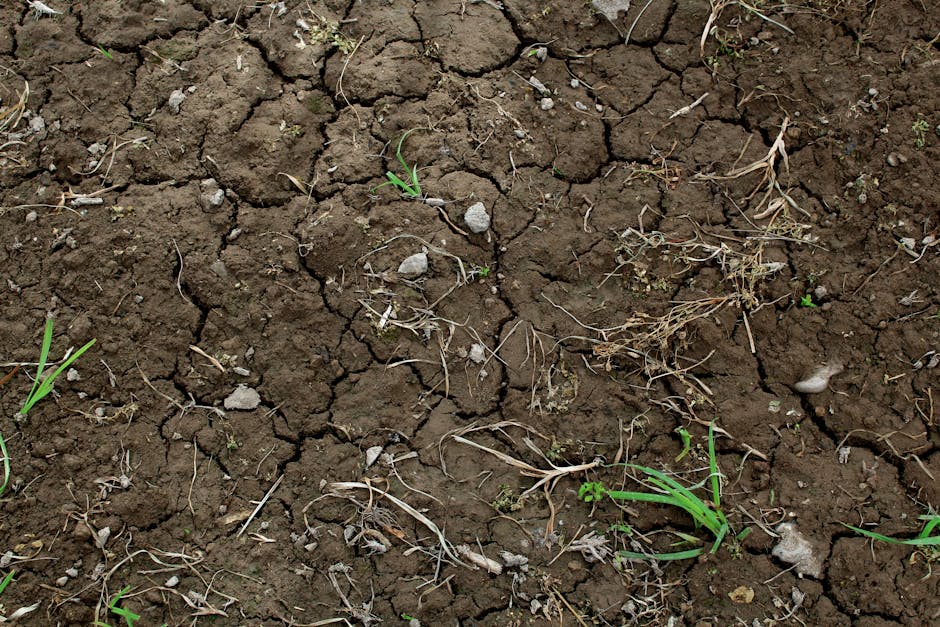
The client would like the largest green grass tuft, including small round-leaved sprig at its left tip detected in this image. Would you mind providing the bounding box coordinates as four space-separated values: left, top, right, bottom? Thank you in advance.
578 425 743 561
